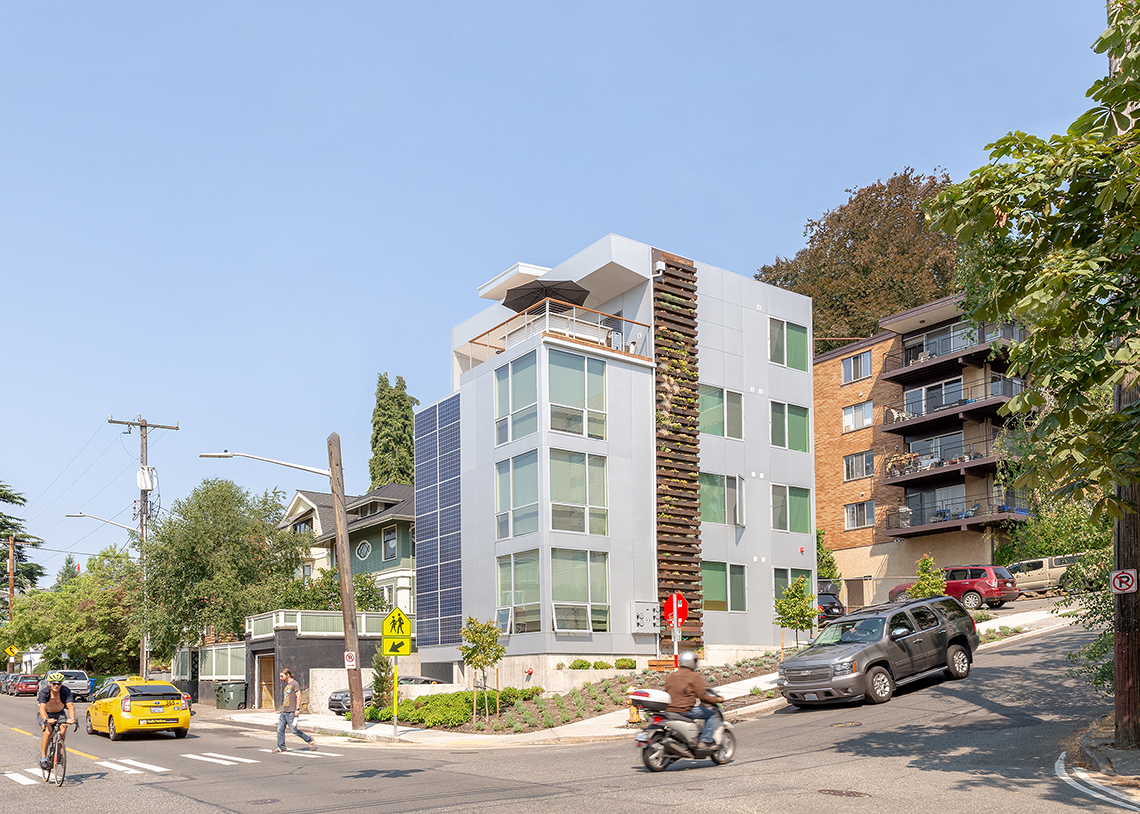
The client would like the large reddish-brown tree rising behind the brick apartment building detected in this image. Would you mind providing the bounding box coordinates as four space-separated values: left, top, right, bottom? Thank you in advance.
756 166 958 353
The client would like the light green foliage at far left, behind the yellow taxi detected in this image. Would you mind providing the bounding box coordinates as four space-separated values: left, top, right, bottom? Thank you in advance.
5 547 140 673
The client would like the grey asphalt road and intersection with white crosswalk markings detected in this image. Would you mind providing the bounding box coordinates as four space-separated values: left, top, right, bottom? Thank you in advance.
0 629 1119 814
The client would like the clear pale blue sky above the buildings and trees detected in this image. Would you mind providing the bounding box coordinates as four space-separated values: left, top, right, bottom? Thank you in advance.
0 0 1106 576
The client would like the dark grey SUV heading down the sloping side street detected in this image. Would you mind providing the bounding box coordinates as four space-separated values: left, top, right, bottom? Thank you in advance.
776 596 979 707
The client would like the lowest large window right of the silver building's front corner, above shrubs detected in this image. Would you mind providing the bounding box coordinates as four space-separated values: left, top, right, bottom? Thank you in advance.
551 548 610 633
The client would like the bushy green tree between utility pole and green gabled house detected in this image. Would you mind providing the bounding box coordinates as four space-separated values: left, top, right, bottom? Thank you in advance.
144 480 306 657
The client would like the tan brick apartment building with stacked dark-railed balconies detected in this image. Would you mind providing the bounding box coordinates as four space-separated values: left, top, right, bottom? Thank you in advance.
813 296 1026 605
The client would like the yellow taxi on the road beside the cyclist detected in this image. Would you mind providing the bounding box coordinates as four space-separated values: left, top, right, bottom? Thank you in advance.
87 676 190 741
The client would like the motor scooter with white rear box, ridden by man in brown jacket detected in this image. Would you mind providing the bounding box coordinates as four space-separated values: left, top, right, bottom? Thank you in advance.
627 690 736 772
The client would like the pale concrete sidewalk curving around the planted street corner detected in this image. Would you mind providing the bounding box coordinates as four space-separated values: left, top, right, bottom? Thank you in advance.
202 611 1069 749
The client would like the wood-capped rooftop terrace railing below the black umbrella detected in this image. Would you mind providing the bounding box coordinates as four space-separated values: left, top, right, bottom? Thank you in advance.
456 299 653 371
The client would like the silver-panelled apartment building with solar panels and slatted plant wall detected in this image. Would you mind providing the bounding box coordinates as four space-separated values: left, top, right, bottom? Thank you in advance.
415 235 815 664
